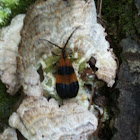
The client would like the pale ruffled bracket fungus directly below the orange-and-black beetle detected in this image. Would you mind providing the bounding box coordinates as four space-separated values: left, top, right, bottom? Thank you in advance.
9 97 98 140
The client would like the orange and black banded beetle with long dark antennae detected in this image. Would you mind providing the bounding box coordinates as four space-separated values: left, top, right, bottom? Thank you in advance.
40 27 79 99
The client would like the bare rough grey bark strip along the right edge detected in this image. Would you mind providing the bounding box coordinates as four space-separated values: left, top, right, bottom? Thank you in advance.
113 37 140 140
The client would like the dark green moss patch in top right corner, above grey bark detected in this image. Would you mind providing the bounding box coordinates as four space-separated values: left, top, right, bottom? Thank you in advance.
102 0 140 44
